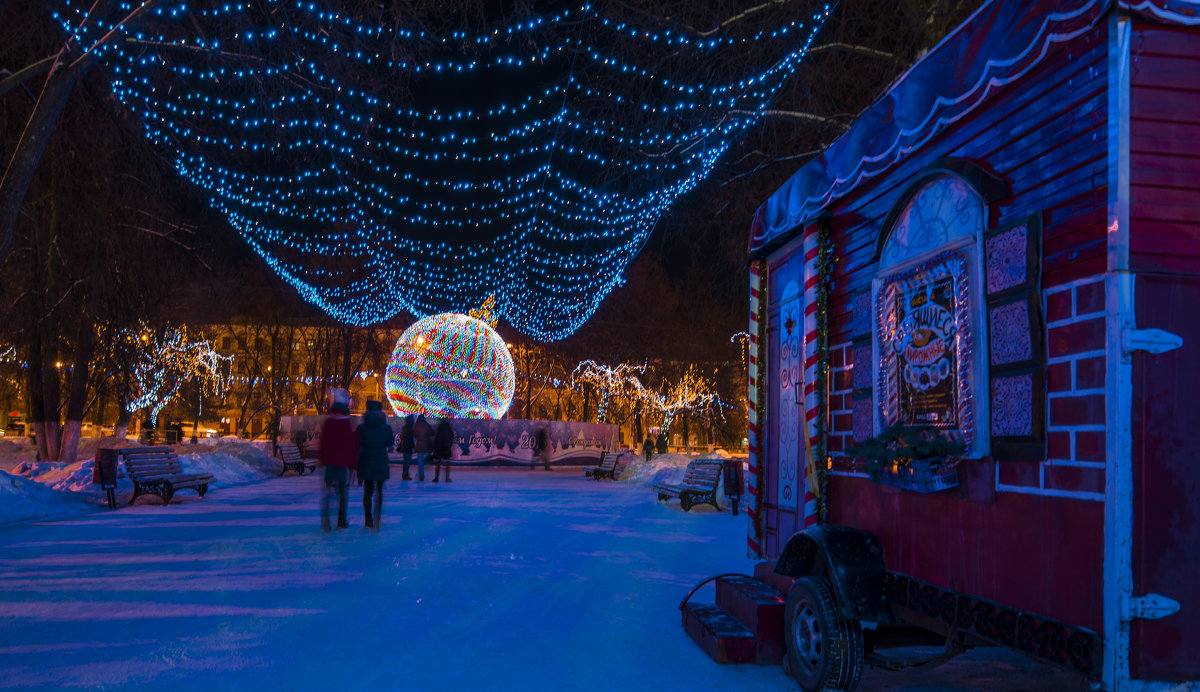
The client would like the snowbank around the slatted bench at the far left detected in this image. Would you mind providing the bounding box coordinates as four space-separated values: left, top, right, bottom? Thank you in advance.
0 438 281 524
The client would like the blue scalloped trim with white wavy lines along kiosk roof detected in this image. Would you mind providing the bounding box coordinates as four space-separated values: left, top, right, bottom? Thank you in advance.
750 0 1200 254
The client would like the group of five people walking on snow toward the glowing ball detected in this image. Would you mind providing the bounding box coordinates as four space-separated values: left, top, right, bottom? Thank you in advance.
320 391 454 531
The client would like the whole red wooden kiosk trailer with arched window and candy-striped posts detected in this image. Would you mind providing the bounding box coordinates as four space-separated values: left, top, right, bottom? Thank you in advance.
685 0 1200 690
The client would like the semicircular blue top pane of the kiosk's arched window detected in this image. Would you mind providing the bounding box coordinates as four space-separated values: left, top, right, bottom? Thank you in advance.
880 175 985 267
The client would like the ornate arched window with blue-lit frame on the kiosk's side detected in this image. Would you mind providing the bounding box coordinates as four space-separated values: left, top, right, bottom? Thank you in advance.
871 172 990 458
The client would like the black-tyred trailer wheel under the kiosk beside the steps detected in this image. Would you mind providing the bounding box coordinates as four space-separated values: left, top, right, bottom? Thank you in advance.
784 577 863 692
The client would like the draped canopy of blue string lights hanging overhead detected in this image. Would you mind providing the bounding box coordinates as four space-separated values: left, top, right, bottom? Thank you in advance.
55 0 830 341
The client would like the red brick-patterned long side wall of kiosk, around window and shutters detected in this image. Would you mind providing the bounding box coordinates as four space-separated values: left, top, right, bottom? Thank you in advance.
801 13 1108 631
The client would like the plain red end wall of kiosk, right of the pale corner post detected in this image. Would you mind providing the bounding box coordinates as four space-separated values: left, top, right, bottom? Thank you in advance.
1129 23 1200 680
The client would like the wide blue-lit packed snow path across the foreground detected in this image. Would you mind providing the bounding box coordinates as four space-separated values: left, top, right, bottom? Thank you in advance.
0 469 1089 692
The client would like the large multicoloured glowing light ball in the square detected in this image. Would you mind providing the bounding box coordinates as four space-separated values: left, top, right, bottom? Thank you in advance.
388 312 516 419
